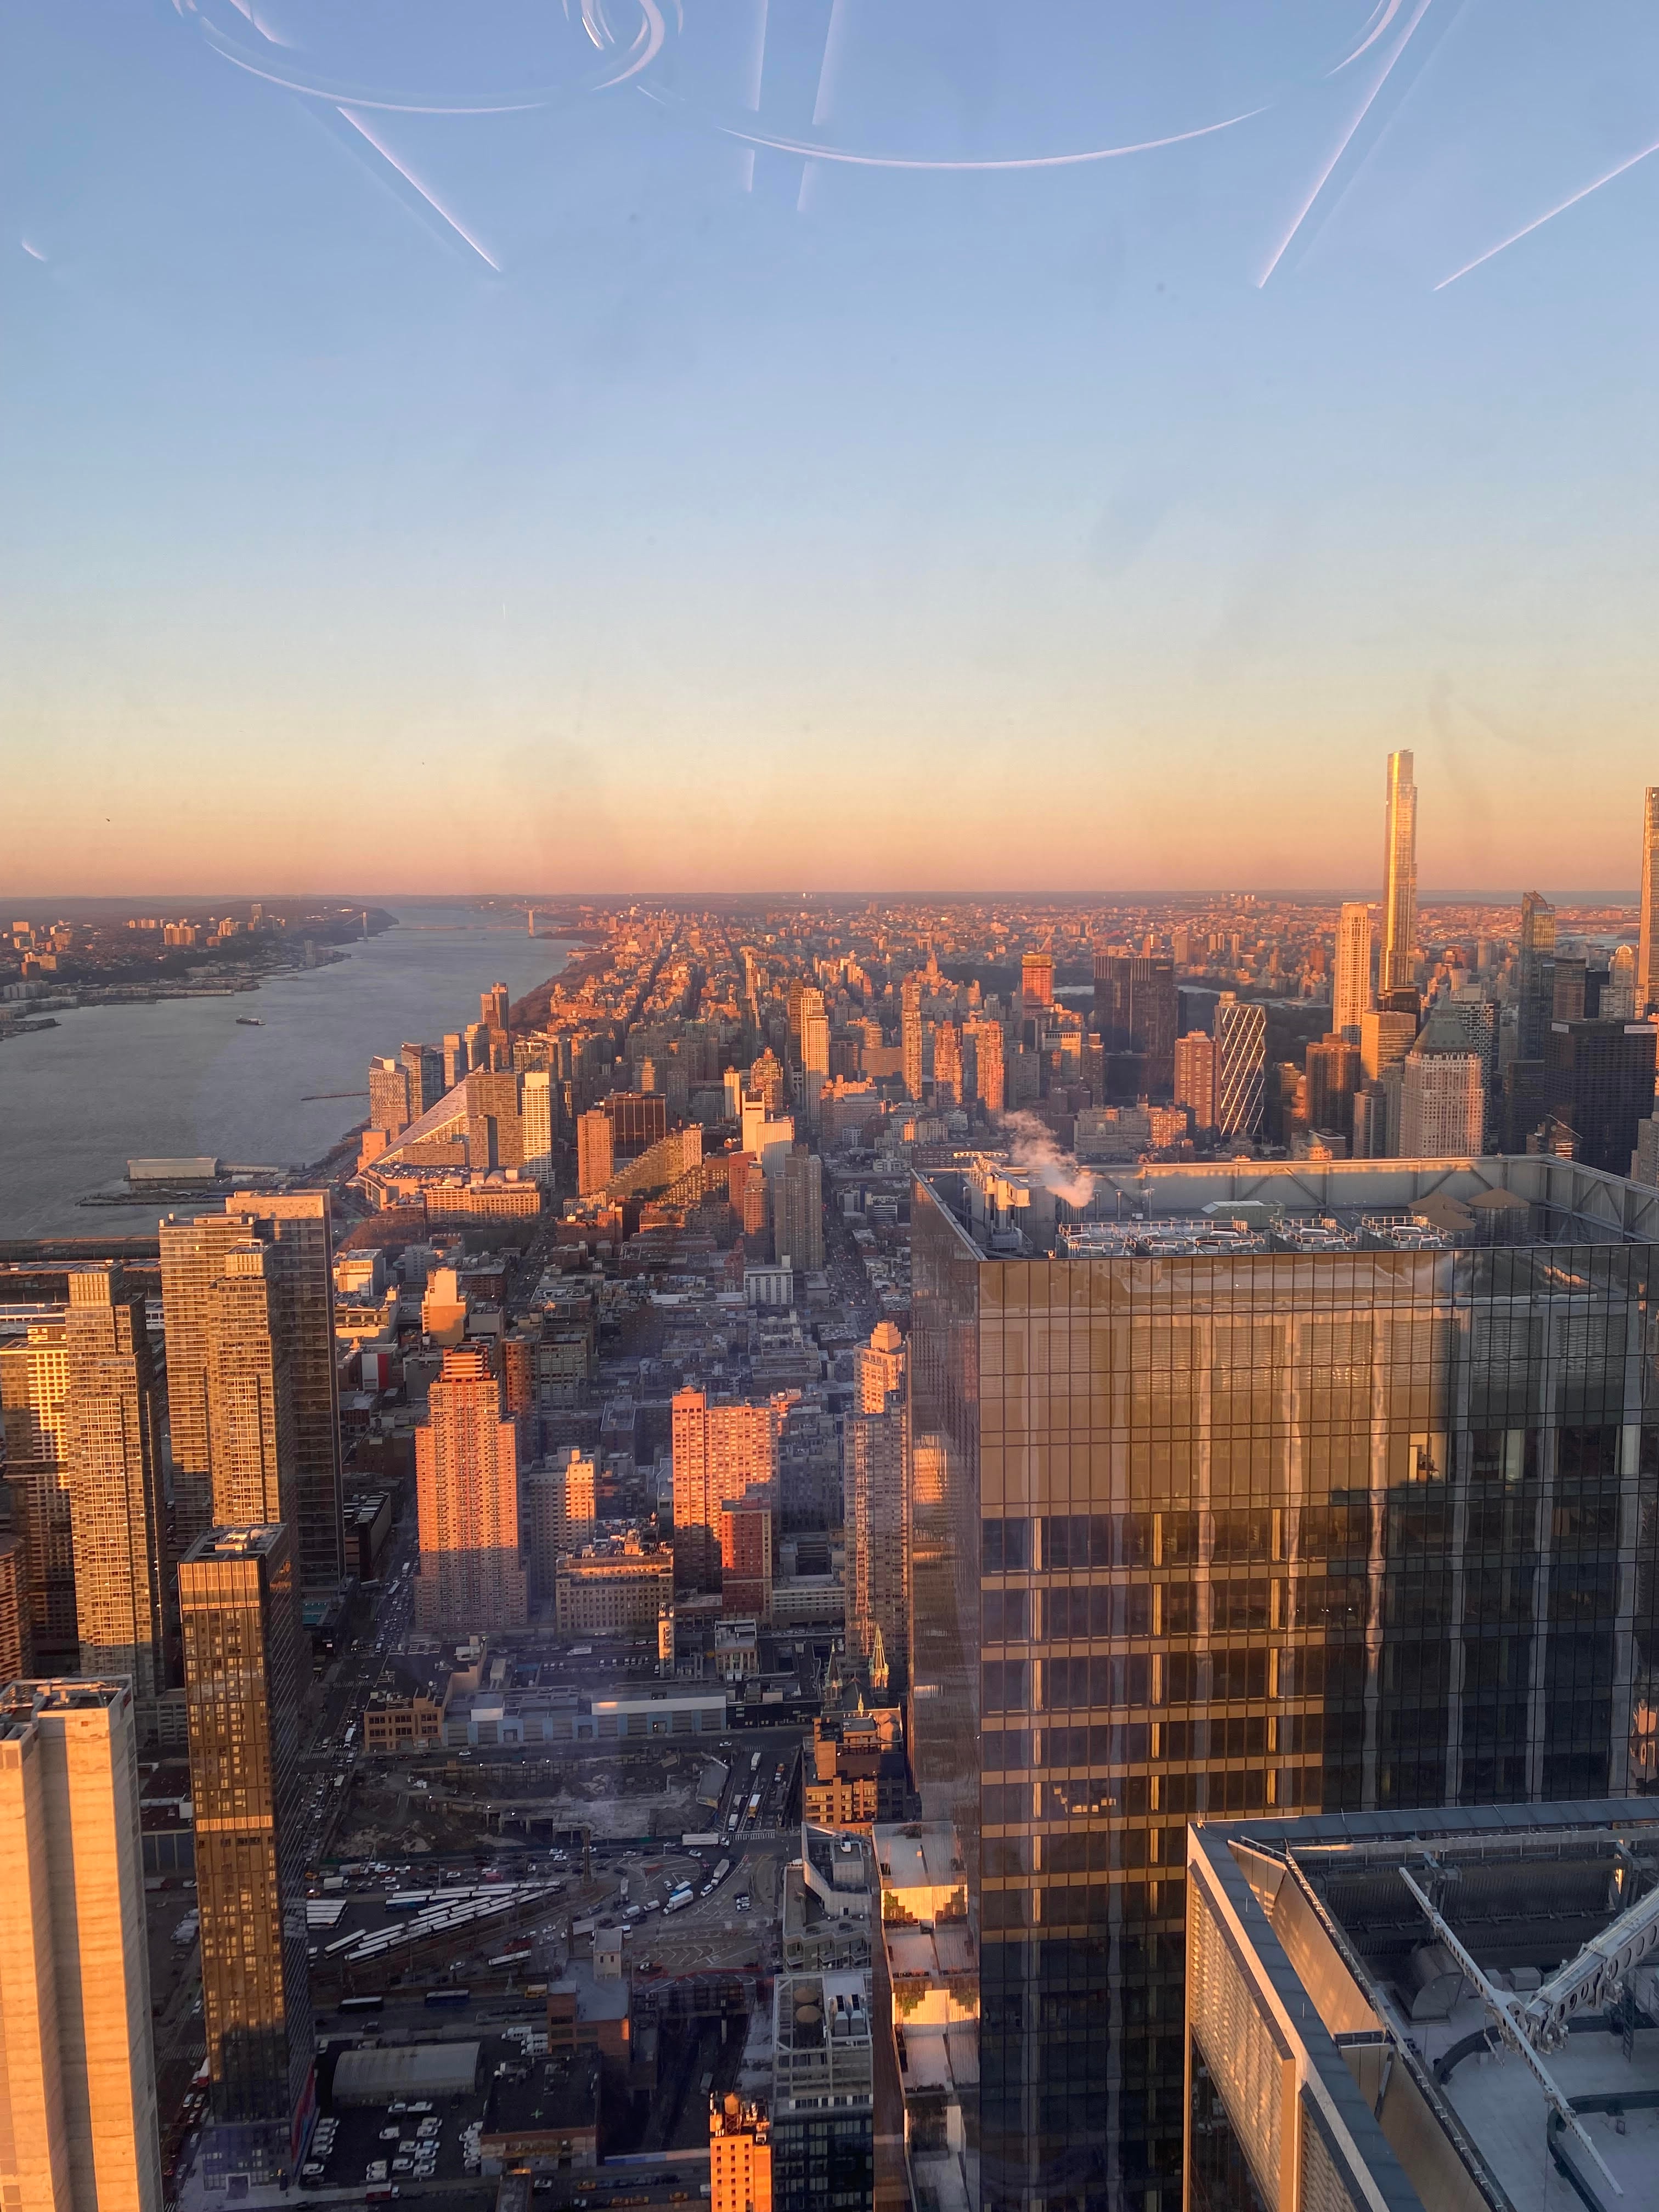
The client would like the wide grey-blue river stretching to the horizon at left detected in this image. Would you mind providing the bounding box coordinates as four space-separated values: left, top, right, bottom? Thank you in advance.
0 900 568 1239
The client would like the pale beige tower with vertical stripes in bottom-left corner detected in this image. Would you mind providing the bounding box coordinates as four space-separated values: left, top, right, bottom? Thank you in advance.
0 1679 163 2212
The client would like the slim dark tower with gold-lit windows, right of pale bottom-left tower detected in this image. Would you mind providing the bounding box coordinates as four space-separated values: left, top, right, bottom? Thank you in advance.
179 1524 314 2188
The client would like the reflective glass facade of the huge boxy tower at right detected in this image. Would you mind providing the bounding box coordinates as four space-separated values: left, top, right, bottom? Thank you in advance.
911 1161 1659 2212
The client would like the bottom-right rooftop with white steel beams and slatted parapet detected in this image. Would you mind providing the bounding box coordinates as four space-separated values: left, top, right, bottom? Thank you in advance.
1188 1798 1659 2212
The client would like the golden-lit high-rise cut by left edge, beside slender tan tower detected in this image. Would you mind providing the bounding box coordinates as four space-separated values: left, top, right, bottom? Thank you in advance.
0 1314 80 1666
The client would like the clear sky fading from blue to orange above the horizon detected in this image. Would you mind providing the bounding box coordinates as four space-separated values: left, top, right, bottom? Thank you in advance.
0 0 1659 894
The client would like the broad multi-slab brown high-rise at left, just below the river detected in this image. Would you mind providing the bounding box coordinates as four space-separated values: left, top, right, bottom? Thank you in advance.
161 1190 345 1590
